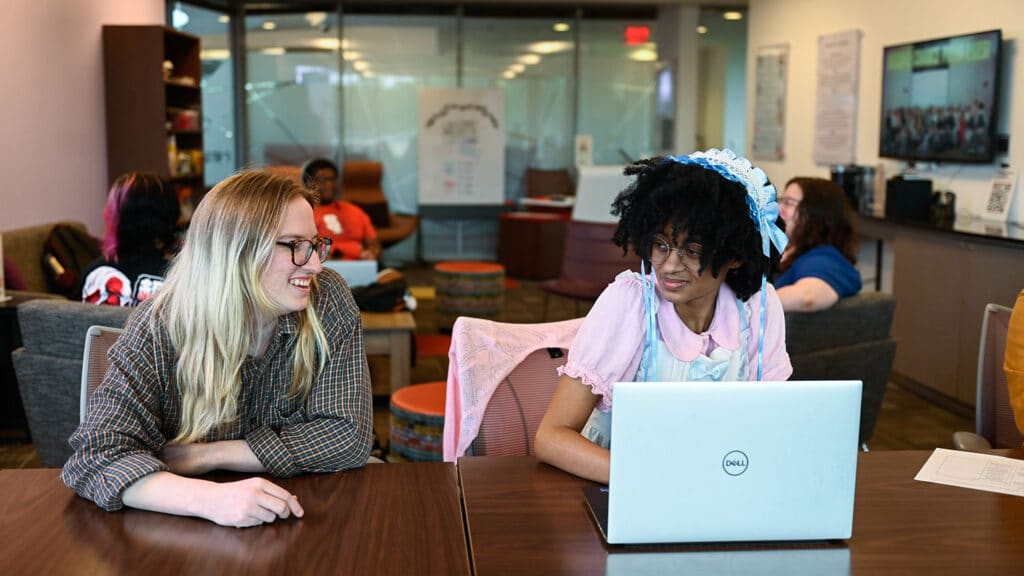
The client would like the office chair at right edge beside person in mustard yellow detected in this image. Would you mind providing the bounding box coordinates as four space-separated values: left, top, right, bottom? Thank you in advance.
953 303 1024 451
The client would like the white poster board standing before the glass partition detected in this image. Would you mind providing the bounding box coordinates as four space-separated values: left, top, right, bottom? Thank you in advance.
419 88 505 205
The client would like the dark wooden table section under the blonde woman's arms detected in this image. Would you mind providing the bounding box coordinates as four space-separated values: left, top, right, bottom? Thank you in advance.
0 462 470 576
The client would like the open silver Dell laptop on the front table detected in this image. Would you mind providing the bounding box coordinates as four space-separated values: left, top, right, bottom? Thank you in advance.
584 380 861 544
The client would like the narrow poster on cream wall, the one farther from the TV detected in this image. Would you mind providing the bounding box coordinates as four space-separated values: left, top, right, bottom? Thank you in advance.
753 45 790 161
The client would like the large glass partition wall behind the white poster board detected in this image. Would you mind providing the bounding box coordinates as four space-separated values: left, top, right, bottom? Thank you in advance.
169 2 671 259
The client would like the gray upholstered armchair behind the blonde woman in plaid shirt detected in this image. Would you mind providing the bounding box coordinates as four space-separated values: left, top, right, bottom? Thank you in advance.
11 299 132 467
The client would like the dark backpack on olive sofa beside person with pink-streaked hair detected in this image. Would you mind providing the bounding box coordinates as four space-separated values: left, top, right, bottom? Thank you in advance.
42 224 101 300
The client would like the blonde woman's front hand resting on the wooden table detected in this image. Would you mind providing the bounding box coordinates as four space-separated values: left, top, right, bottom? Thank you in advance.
197 478 305 528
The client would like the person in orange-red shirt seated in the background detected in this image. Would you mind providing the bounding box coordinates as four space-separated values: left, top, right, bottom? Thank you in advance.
302 158 381 260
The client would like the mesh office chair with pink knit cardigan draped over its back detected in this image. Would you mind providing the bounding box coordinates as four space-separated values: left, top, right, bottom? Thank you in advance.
443 317 583 462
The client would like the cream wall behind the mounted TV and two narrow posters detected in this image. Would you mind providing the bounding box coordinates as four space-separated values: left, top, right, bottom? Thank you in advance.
746 0 1024 222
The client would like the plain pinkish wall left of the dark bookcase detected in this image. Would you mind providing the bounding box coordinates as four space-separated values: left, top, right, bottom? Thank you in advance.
0 0 164 235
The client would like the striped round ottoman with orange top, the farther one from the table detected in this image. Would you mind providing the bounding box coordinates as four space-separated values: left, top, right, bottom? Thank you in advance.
434 260 505 332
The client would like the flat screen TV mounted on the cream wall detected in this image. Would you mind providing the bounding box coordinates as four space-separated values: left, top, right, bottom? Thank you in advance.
879 30 1002 163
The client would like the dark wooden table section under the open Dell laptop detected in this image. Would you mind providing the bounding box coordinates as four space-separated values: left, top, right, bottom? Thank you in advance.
459 450 1024 576
